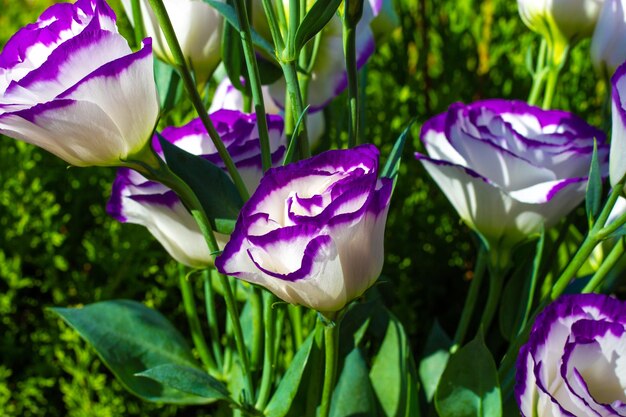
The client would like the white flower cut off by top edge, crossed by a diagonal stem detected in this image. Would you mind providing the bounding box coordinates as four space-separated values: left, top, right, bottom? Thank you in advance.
122 0 224 82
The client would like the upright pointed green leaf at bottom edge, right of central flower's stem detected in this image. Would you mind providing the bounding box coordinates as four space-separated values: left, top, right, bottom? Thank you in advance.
330 348 376 417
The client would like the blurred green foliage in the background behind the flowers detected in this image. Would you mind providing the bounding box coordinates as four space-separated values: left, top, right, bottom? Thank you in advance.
0 0 606 417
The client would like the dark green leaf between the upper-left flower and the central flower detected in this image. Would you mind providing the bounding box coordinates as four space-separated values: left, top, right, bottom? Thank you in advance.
157 133 243 233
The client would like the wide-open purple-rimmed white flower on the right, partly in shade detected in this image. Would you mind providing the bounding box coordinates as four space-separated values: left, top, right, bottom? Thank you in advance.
415 100 607 249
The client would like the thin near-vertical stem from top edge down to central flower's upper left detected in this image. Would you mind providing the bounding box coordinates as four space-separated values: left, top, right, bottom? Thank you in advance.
229 0 272 171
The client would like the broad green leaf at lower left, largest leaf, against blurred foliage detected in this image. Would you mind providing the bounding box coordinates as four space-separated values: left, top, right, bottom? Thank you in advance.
51 300 212 404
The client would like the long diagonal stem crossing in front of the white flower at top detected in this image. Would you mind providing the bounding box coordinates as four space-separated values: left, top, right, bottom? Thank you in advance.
149 0 250 201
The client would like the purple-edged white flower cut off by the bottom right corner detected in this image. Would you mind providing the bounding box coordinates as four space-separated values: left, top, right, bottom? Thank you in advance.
515 294 626 417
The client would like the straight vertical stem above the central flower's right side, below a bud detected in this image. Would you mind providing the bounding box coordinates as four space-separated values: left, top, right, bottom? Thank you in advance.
343 22 360 148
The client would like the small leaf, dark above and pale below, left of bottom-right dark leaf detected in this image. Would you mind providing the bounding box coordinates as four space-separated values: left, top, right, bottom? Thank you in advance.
419 320 452 402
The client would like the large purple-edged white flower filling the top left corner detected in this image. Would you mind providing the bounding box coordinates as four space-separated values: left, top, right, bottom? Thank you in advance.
0 0 159 166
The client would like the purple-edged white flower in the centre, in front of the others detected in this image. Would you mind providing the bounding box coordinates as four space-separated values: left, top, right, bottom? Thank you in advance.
215 145 392 312
